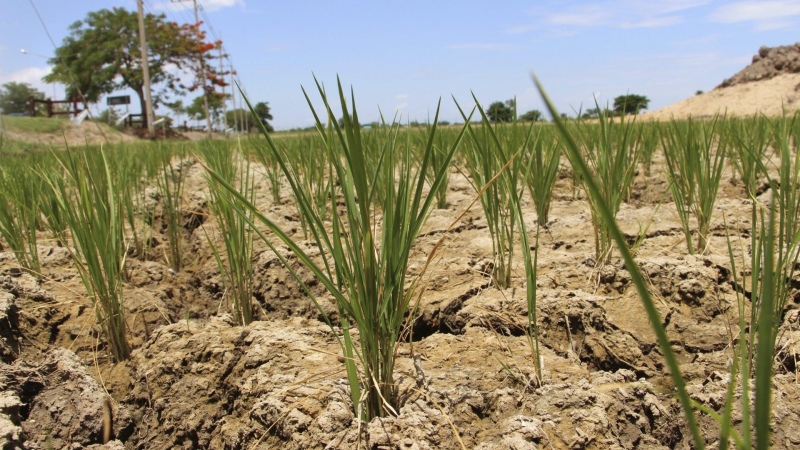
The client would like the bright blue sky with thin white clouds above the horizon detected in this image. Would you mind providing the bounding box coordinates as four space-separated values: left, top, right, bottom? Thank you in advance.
0 0 800 129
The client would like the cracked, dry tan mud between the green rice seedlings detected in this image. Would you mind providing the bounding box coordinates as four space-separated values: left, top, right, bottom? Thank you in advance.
0 153 800 450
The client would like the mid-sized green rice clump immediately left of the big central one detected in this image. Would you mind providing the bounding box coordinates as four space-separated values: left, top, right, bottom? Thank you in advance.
201 144 255 325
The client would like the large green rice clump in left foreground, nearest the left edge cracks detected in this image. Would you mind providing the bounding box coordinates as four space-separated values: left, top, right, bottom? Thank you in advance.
44 149 130 361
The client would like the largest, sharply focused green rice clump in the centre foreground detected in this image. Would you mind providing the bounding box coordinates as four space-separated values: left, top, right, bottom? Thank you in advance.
210 78 463 421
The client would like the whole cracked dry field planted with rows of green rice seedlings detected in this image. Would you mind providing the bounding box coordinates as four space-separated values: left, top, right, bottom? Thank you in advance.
0 96 800 450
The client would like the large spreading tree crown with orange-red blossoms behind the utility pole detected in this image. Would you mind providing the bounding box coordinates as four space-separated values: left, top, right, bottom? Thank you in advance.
44 8 225 125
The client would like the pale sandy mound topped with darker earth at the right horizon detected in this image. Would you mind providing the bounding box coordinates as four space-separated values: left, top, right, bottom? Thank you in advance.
642 43 800 120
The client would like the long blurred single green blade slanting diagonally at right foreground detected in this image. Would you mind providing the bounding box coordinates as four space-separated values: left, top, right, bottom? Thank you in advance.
534 77 705 449
